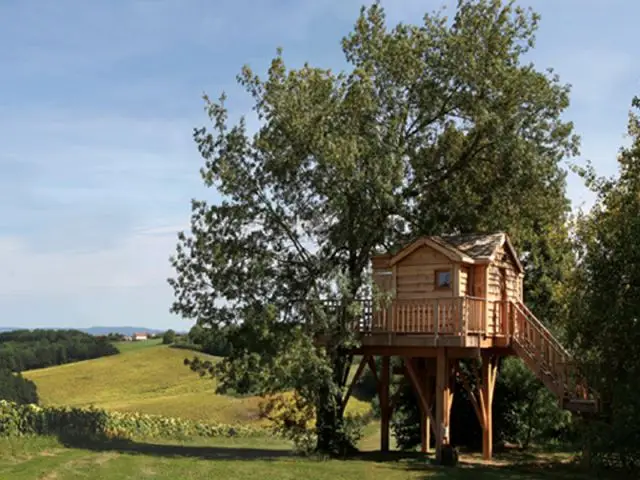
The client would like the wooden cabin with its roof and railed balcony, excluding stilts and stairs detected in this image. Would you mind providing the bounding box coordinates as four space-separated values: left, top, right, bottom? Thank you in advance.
365 233 524 347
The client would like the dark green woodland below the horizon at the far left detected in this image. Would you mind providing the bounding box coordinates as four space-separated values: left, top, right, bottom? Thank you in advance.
0 329 118 372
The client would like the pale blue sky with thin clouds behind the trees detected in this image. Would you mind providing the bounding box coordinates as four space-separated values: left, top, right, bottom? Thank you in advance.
0 0 640 329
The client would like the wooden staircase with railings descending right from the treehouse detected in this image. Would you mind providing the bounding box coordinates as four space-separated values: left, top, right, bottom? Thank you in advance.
509 301 599 413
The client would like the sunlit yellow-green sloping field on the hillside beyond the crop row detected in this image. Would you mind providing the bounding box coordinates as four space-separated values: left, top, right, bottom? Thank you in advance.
24 340 369 424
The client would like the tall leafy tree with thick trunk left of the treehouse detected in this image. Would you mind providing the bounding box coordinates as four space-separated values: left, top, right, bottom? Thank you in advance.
170 0 577 452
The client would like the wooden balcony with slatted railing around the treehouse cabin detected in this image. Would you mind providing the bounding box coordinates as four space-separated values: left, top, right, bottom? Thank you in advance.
358 296 513 348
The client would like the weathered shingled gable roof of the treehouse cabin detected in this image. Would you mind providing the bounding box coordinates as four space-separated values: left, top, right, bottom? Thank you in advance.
382 232 524 272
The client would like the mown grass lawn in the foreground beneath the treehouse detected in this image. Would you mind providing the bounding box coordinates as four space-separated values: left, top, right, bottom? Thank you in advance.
0 438 589 480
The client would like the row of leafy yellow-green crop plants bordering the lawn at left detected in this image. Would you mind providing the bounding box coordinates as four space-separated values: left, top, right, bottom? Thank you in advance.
0 400 267 439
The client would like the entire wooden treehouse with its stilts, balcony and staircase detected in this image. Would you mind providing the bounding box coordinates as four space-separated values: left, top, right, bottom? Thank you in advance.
345 233 597 459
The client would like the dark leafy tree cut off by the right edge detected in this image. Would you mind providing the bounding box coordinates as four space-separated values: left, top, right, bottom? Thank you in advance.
568 94 640 473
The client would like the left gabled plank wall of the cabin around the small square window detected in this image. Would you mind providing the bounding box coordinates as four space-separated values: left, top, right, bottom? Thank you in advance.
394 246 459 300
